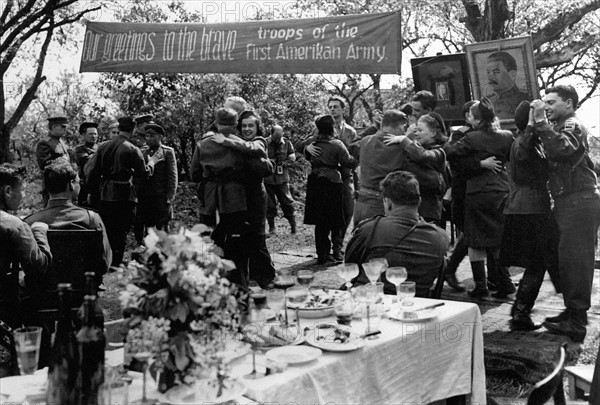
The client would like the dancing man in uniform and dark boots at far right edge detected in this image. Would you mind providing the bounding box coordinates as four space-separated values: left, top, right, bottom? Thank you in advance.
531 85 600 342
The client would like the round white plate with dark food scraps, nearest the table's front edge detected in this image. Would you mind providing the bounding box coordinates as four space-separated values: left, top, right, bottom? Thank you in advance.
306 323 365 352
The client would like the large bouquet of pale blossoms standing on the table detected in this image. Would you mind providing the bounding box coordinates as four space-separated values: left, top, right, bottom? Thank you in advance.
112 225 243 396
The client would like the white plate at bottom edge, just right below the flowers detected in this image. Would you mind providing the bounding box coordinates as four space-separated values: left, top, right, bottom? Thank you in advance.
164 379 248 405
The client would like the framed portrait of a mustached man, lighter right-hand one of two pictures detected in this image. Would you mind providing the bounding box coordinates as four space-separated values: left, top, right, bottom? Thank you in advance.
465 36 539 127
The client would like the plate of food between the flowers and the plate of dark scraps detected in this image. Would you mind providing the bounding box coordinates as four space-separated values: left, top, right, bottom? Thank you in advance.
242 322 305 349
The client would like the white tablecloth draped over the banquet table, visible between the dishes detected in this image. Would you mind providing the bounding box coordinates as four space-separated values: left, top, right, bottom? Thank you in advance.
0 296 486 405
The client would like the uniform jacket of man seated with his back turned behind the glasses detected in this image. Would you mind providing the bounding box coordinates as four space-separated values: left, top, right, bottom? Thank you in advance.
345 208 449 297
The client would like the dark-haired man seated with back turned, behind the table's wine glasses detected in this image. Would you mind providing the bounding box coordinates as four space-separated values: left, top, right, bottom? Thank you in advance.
345 171 449 297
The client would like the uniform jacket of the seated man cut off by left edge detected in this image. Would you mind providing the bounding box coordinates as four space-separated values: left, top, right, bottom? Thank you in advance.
0 210 52 327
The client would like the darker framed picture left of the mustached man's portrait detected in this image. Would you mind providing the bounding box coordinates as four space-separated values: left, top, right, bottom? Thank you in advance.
410 53 471 122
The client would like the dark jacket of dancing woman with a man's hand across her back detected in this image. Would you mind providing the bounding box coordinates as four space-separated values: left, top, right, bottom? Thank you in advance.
445 130 513 194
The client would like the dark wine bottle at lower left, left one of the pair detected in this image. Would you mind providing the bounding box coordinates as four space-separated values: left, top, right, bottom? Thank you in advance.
46 283 81 405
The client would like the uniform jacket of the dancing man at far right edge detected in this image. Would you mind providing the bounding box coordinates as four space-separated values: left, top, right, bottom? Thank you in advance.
533 113 597 197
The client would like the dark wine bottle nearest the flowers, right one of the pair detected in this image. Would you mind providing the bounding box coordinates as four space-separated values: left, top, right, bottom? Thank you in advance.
77 295 106 405
